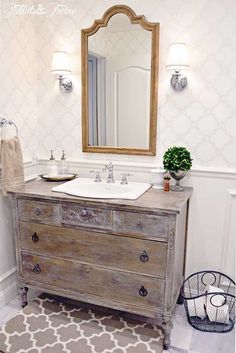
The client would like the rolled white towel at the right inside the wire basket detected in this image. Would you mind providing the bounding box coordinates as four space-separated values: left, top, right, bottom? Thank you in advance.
206 286 229 324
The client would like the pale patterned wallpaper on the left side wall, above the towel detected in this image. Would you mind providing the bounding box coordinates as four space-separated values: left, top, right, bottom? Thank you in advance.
0 0 38 160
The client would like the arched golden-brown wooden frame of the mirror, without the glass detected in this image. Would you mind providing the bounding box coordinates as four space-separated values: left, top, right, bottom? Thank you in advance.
81 5 159 156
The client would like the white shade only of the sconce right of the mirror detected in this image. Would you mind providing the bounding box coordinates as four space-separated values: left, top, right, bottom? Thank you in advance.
166 43 189 71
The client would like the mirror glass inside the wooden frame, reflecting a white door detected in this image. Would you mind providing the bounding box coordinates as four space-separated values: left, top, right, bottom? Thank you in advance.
88 14 151 148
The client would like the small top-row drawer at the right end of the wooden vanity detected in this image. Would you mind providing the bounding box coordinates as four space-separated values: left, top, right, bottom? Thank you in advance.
113 211 168 238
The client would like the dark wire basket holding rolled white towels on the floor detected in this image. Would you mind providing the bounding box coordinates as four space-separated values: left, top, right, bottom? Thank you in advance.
180 271 235 333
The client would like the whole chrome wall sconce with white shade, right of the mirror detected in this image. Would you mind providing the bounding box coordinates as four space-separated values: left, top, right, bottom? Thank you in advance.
166 43 189 91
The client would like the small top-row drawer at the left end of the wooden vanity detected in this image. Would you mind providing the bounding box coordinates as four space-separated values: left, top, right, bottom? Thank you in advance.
18 199 60 224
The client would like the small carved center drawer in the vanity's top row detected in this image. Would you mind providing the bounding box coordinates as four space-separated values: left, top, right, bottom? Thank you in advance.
62 203 112 229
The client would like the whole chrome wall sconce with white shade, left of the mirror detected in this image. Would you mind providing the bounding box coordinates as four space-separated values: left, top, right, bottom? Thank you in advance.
51 51 72 93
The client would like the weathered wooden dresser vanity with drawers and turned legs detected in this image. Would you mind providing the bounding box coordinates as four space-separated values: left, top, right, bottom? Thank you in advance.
10 180 191 347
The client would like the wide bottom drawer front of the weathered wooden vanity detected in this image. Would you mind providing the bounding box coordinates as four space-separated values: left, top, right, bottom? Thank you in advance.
22 254 164 312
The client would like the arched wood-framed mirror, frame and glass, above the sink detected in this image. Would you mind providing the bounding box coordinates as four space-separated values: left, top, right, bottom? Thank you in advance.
81 5 159 156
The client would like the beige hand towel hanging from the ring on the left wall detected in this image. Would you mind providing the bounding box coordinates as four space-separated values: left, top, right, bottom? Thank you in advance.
0 136 25 196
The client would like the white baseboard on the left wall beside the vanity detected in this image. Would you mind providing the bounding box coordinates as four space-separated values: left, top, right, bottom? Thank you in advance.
0 267 18 309
